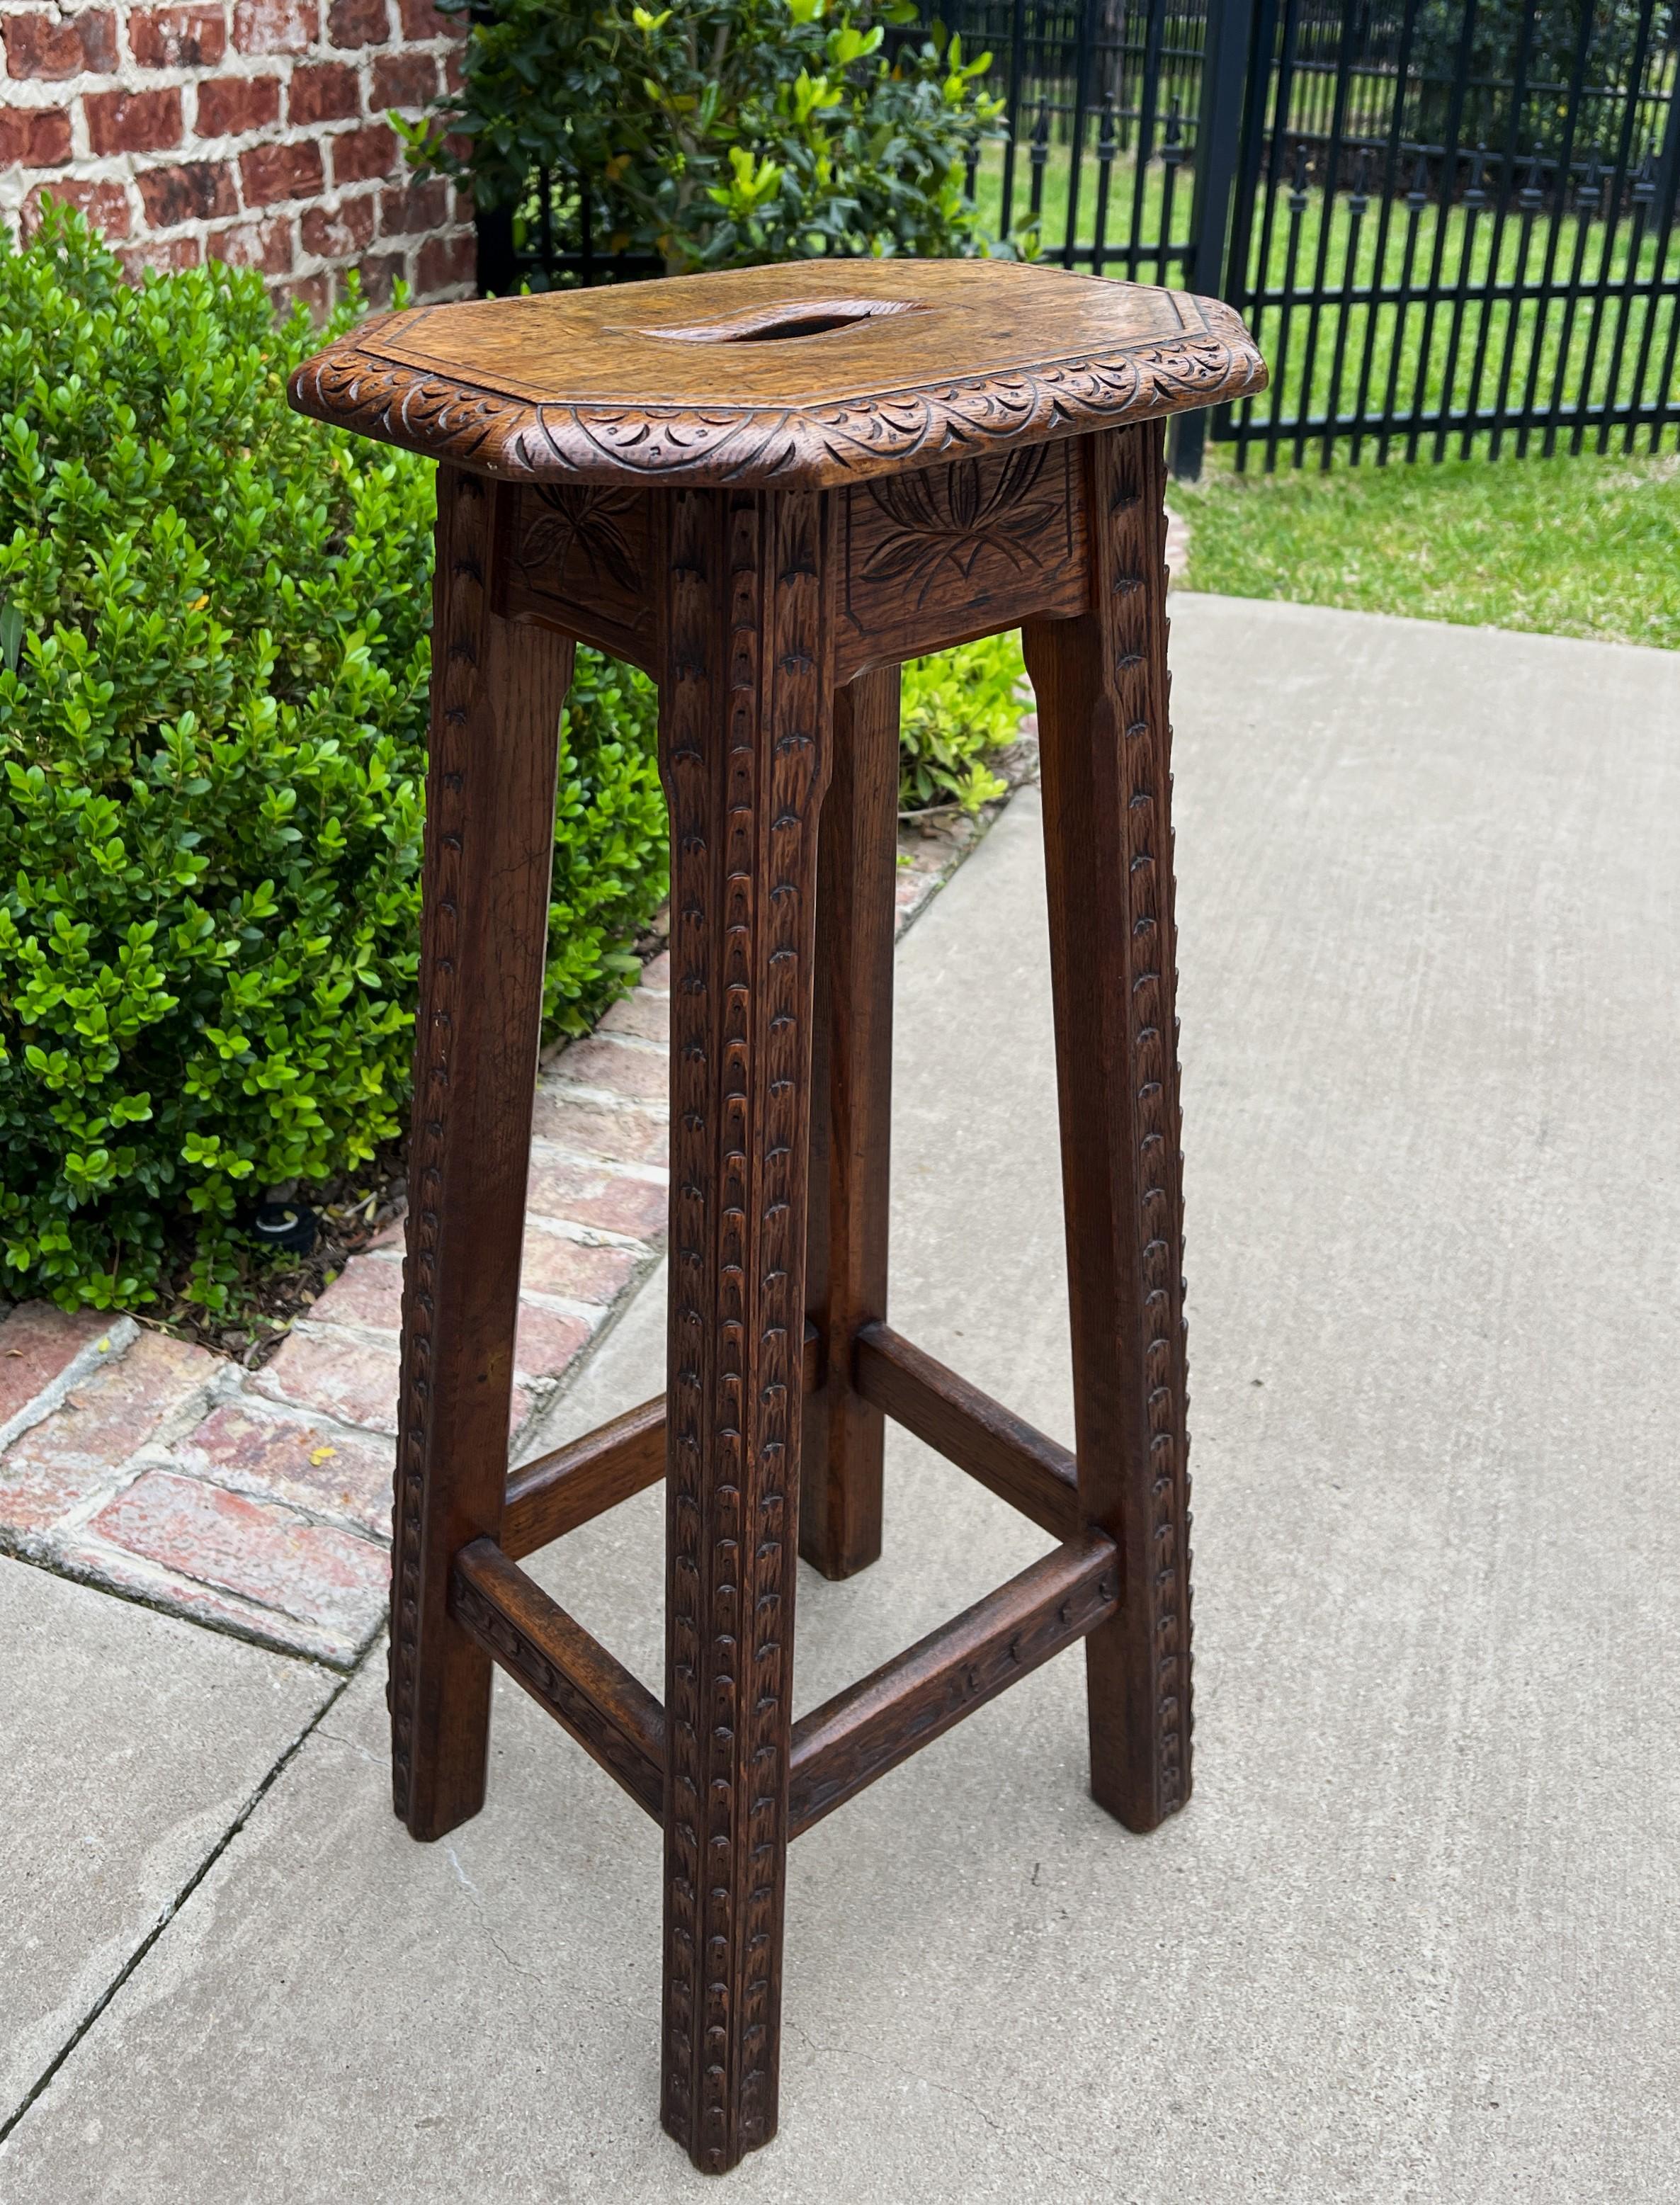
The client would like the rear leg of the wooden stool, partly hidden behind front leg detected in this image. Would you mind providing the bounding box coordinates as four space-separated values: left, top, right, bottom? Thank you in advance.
798 666 899 1577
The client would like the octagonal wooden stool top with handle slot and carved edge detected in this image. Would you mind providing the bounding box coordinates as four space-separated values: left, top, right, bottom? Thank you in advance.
291 260 1266 487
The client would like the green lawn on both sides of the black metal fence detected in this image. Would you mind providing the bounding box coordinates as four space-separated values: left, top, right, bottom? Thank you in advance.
961 124 1680 650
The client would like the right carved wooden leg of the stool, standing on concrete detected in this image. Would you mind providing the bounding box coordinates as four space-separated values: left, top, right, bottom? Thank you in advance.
1025 424 1191 1830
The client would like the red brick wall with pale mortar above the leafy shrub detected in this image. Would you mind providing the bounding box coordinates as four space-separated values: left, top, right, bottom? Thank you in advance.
0 0 472 311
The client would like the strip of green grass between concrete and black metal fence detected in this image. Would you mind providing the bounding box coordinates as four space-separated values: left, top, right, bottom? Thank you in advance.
1171 448 1680 650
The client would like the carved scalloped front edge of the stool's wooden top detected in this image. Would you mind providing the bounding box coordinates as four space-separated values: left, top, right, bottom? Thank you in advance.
289 278 1266 489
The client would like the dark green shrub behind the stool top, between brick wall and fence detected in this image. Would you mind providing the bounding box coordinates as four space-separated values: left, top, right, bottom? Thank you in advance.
404 0 1001 276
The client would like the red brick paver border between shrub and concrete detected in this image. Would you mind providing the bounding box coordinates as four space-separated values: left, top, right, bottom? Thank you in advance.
0 767 1032 1667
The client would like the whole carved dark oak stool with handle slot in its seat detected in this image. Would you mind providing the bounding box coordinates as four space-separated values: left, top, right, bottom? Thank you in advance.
291 260 1264 2170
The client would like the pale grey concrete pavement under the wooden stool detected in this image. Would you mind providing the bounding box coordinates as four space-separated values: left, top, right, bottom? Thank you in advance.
0 598 1680 2205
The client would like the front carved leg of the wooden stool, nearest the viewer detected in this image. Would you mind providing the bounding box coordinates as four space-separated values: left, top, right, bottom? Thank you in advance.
659 492 832 2172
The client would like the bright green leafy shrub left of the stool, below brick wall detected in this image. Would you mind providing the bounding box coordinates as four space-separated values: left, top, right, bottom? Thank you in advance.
0 212 666 1308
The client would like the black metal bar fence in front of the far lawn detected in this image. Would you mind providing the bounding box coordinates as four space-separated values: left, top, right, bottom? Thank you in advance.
481 0 1680 472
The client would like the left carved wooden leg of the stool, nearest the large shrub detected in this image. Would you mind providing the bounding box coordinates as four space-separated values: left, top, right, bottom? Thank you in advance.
390 467 571 1839
